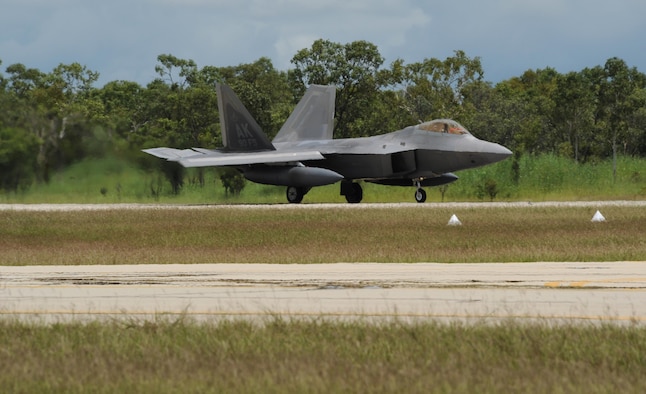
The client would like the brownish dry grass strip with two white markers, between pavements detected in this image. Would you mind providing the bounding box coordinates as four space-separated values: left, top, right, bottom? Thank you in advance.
0 207 646 265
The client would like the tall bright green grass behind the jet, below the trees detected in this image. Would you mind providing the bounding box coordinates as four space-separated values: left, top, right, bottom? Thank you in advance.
0 153 646 204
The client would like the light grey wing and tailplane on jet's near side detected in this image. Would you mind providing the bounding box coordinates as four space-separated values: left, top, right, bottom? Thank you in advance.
144 148 324 167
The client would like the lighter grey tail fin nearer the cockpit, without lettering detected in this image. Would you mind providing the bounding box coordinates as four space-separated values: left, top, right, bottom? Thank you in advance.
273 85 336 142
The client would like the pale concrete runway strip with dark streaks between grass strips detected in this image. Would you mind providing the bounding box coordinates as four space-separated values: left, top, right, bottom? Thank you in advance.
0 262 646 326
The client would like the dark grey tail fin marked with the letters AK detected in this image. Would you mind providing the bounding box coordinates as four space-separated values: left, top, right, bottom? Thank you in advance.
216 84 275 152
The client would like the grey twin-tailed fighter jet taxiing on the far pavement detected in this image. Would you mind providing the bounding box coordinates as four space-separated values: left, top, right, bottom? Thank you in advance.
143 84 511 203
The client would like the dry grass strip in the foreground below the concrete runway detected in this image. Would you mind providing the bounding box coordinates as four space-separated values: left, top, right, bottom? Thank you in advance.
0 319 646 393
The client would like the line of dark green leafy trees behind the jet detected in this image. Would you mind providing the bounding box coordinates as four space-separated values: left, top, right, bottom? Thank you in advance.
0 40 646 192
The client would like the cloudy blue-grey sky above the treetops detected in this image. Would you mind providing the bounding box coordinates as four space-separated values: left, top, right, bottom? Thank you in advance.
0 0 646 87
